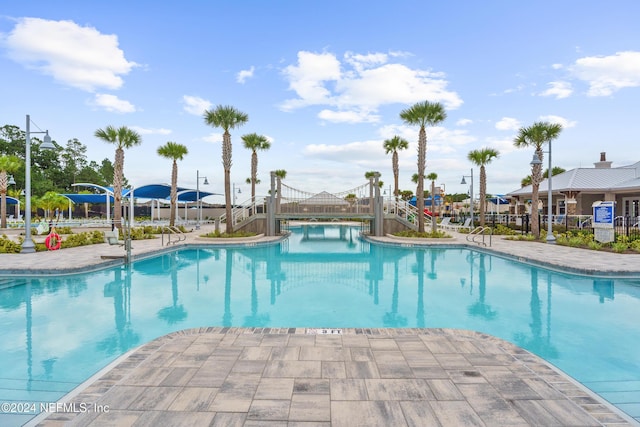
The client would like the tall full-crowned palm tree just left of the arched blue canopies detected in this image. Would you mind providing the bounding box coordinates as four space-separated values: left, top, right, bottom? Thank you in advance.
94 125 142 228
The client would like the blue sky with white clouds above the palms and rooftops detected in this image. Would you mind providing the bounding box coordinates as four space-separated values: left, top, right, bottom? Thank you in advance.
0 0 640 201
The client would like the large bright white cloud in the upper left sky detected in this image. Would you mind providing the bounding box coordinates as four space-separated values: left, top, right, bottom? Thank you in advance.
2 18 137 92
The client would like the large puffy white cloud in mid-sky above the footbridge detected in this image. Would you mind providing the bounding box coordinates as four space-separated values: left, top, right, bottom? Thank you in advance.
281 51 462 122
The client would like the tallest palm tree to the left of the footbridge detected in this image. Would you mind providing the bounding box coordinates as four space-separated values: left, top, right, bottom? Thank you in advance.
204 105 249 234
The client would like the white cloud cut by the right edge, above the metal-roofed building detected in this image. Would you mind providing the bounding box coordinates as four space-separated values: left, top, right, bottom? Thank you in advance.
571 51 640 96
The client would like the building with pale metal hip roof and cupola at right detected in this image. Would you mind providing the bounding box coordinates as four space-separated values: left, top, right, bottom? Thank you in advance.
507 153 640 218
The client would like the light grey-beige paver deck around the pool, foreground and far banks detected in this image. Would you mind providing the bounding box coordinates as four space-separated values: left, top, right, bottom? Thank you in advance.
0 227 640 426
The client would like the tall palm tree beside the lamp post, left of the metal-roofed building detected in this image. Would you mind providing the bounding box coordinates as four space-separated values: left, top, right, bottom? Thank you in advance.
513 122 562 238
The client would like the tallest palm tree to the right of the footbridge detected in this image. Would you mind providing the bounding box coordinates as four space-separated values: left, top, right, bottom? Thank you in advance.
400 101 447 231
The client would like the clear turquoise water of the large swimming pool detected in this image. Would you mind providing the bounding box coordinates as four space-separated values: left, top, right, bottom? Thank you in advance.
0 225 640 425
